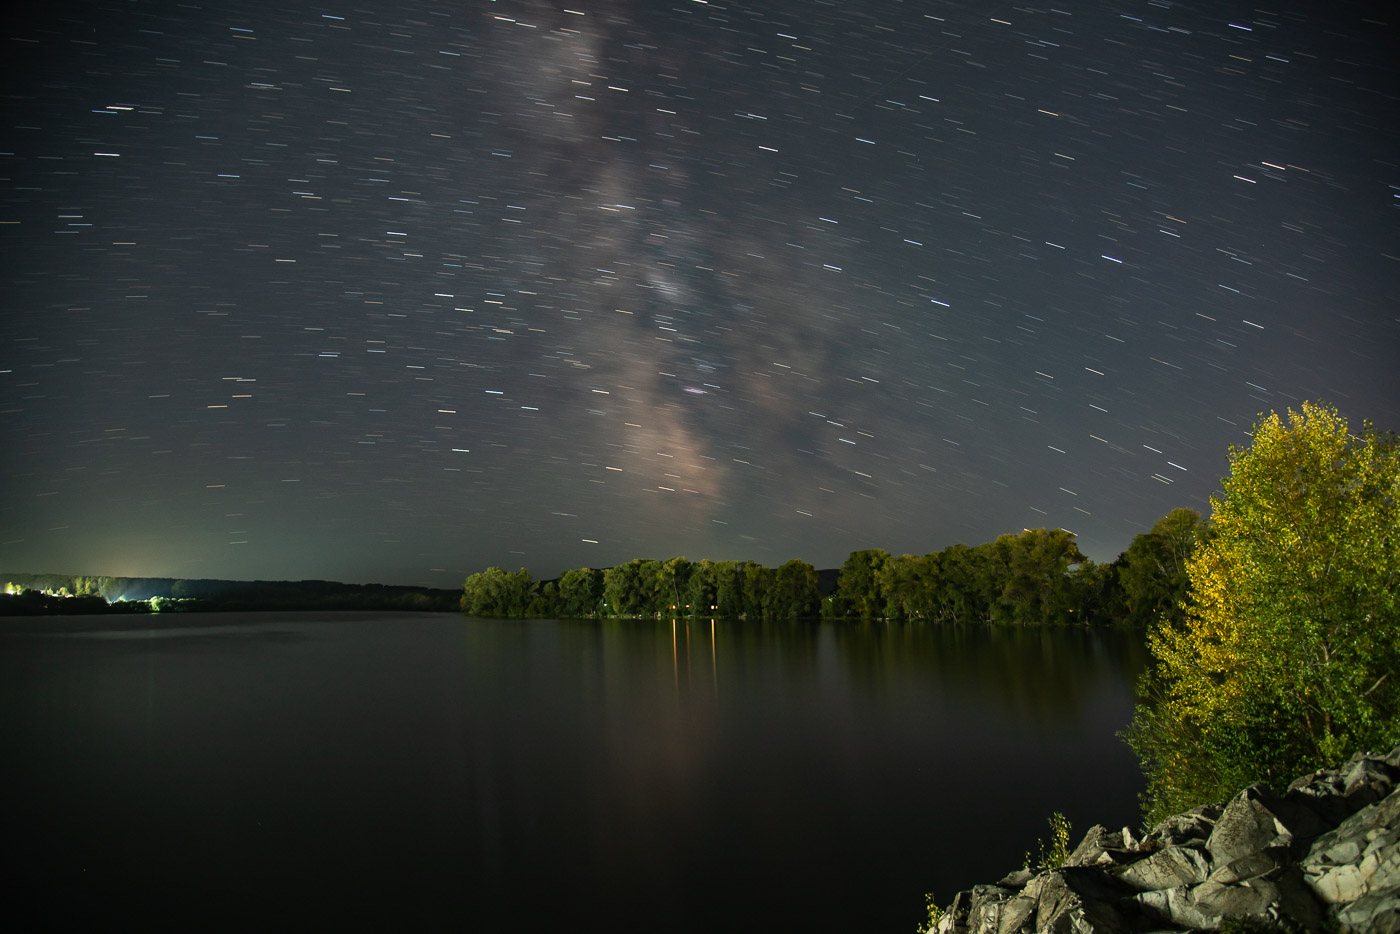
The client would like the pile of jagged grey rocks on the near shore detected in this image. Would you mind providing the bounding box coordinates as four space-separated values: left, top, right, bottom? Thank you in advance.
935 746 1400 934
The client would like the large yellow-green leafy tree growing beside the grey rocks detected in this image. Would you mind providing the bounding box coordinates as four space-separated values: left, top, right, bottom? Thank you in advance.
1127 403 1400 819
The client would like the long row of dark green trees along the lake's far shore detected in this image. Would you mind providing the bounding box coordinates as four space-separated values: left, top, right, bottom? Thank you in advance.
461 510 1204 625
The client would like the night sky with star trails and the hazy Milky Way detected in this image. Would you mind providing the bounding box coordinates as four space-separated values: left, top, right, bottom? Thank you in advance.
0 0 1400 587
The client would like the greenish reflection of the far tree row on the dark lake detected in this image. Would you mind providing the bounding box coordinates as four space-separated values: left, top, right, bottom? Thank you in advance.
492 619 1148 718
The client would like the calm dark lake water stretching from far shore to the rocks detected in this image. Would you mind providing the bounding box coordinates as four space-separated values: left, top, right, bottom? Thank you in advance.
0 613 1144 934
